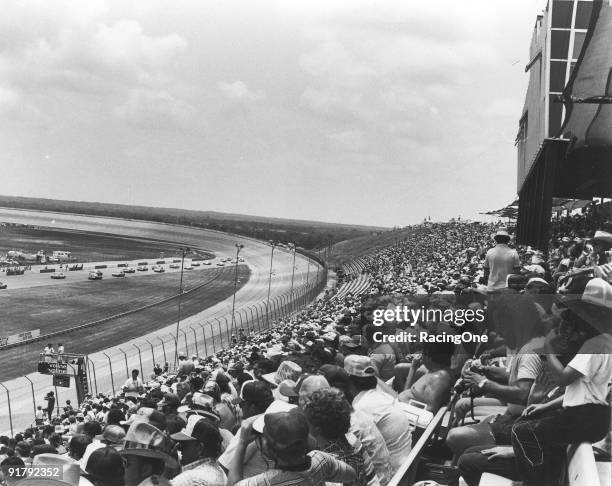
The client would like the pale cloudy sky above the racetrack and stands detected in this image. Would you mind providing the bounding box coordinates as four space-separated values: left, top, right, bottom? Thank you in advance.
0 0 546 227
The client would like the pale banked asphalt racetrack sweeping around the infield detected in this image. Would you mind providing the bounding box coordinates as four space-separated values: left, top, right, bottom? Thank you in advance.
0 208 323 433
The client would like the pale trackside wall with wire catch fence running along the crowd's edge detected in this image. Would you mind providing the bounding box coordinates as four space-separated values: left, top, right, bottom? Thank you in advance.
0 258 327 435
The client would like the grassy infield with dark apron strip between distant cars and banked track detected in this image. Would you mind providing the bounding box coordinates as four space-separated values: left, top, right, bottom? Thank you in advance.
0 265 249 381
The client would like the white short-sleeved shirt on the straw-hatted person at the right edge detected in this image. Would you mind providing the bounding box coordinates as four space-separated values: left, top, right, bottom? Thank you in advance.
563 335 612 407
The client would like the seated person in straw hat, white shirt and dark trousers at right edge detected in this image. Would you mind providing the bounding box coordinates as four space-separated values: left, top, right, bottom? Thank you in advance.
512 278 612 486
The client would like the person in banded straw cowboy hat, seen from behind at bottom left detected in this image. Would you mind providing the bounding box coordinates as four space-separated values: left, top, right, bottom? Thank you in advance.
119 421 178 486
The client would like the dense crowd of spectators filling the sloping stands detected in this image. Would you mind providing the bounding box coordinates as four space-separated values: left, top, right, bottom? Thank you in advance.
0 211 612 486
